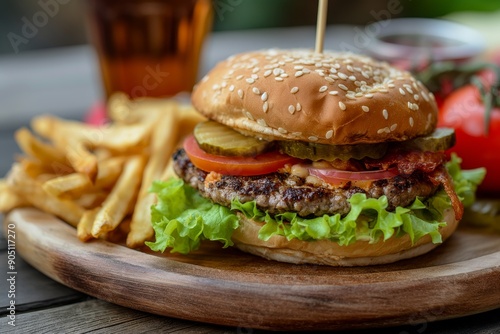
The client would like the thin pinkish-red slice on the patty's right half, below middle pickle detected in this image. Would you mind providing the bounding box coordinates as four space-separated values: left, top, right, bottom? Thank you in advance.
308 167 399 185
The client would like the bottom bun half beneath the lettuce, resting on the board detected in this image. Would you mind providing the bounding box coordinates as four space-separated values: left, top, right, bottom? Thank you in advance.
232 208 458 266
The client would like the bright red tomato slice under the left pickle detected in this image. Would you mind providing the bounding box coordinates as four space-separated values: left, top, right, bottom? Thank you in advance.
184 135 300 176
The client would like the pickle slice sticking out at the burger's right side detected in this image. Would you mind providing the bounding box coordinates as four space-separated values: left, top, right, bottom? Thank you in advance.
398 128 456 152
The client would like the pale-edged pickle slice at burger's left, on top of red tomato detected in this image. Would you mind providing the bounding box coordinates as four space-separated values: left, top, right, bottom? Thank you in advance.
194 121 271 157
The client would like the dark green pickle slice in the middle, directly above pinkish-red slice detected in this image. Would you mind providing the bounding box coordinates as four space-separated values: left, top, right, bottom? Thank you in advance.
279 141 389 161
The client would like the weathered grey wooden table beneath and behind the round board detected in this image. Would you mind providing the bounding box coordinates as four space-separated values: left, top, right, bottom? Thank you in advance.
0 27 500 334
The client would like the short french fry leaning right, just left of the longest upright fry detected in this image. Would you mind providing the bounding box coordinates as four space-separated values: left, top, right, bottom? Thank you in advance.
92 156 144 238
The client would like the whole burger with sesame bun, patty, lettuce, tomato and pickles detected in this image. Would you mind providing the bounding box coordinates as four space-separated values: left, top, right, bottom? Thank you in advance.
148 49 484 266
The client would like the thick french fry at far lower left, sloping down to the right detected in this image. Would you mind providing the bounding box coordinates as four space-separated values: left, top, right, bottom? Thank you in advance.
7 165 84 227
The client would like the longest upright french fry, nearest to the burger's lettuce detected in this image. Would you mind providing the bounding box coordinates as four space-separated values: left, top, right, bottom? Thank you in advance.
127 104 178 248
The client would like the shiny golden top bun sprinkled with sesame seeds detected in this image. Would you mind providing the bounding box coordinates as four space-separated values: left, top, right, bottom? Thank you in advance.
192 50 437 145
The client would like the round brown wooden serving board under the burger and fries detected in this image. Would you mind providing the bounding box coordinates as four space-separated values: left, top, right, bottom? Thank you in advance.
4 208 500 330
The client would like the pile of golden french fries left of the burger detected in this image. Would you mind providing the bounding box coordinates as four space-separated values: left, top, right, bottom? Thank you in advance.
0 94 203 248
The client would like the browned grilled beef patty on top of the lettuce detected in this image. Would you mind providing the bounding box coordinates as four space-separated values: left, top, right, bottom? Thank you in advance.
174 149 439 217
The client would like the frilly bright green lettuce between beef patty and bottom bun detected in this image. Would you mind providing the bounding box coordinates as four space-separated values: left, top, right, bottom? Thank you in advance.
146 155 485 253
